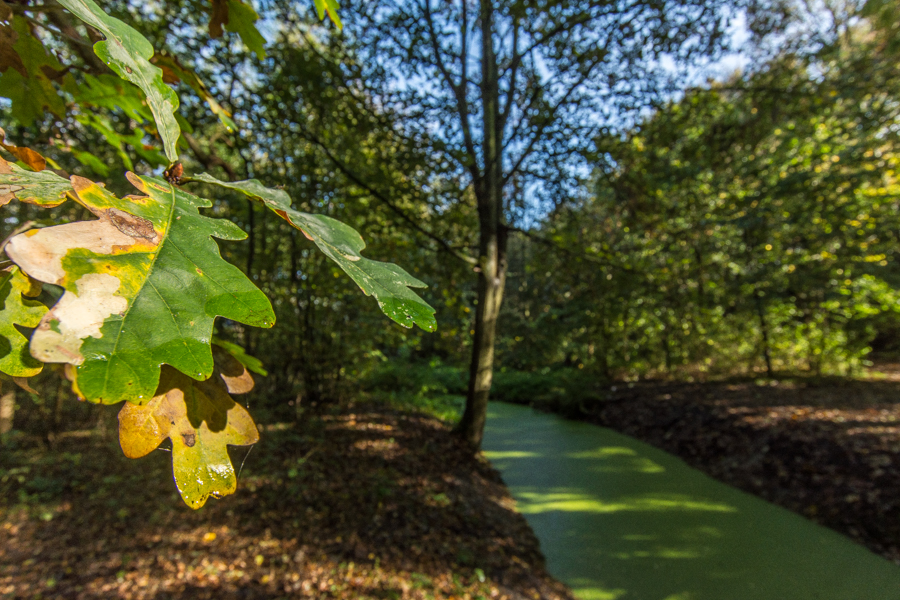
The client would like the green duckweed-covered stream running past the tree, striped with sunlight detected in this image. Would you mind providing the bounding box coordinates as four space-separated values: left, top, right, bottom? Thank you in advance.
484 403 900 600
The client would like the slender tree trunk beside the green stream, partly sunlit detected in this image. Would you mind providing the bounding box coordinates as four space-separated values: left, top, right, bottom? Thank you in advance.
459 0 507 450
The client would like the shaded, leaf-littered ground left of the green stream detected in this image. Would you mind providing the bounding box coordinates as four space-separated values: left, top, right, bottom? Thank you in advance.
0 406 572 600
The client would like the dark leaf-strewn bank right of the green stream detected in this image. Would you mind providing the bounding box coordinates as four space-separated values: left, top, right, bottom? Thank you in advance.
584 365 900 564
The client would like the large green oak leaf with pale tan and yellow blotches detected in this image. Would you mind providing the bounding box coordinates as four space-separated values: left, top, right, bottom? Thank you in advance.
7 173 275 404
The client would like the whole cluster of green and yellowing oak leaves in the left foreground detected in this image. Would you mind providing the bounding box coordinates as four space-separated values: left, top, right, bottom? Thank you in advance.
0 0 435 508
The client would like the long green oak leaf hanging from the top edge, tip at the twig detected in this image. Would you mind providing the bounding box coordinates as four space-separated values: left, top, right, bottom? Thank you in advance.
59 0 181 162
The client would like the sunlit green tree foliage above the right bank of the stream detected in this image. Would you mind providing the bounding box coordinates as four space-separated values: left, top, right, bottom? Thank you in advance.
501 11 900 379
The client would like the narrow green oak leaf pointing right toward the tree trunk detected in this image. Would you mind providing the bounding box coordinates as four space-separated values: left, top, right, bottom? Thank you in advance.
193 173 437 331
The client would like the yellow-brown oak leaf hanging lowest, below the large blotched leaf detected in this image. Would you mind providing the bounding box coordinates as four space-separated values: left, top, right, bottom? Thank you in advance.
119 352 259 509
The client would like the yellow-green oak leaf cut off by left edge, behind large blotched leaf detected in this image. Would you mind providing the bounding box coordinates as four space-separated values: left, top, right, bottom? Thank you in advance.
0 263 47 377
